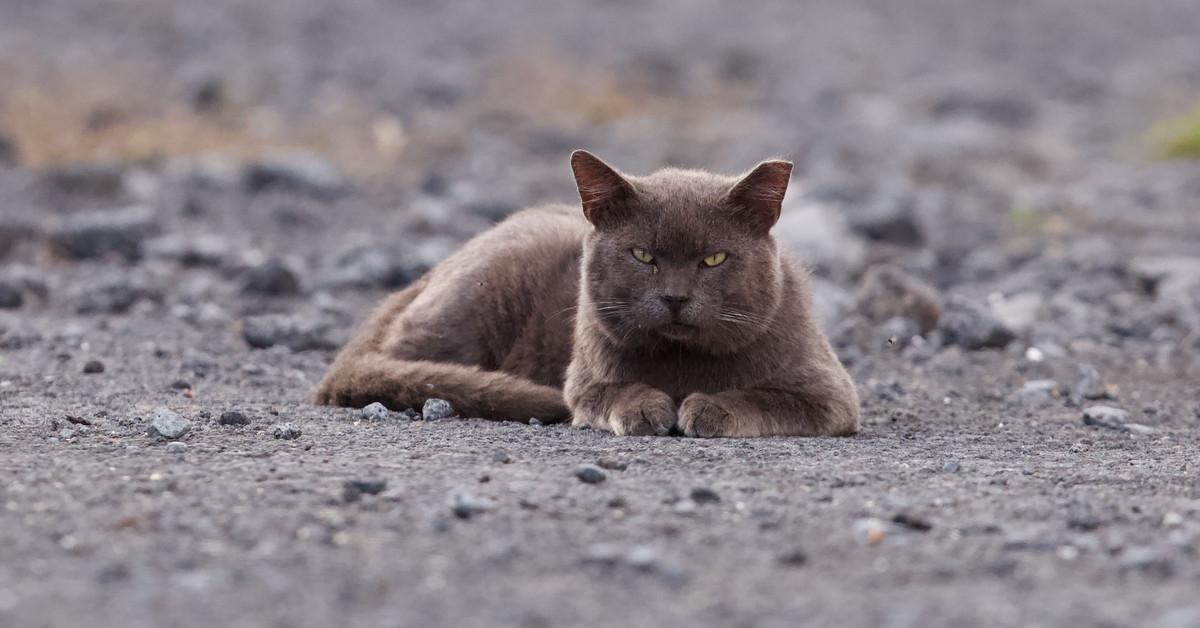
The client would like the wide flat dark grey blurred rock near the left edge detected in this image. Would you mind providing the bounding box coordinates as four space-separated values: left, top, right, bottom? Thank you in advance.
49 205 158 262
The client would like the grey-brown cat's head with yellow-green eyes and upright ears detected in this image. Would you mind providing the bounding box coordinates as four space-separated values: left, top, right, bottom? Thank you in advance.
571 150 792 353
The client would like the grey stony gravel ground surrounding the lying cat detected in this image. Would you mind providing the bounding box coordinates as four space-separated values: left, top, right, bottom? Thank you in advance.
0 0 1200 628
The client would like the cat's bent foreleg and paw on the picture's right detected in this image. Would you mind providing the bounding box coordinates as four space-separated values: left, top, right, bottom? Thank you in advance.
679 382 858 438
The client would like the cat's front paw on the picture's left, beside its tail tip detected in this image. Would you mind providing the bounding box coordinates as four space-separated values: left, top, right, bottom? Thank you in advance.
569 383 676 436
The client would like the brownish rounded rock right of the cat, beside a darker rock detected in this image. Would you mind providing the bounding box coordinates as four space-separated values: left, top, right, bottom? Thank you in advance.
857 264 942 334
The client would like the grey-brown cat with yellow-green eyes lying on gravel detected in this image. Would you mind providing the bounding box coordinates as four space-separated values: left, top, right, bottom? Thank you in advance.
316 150 859 437
